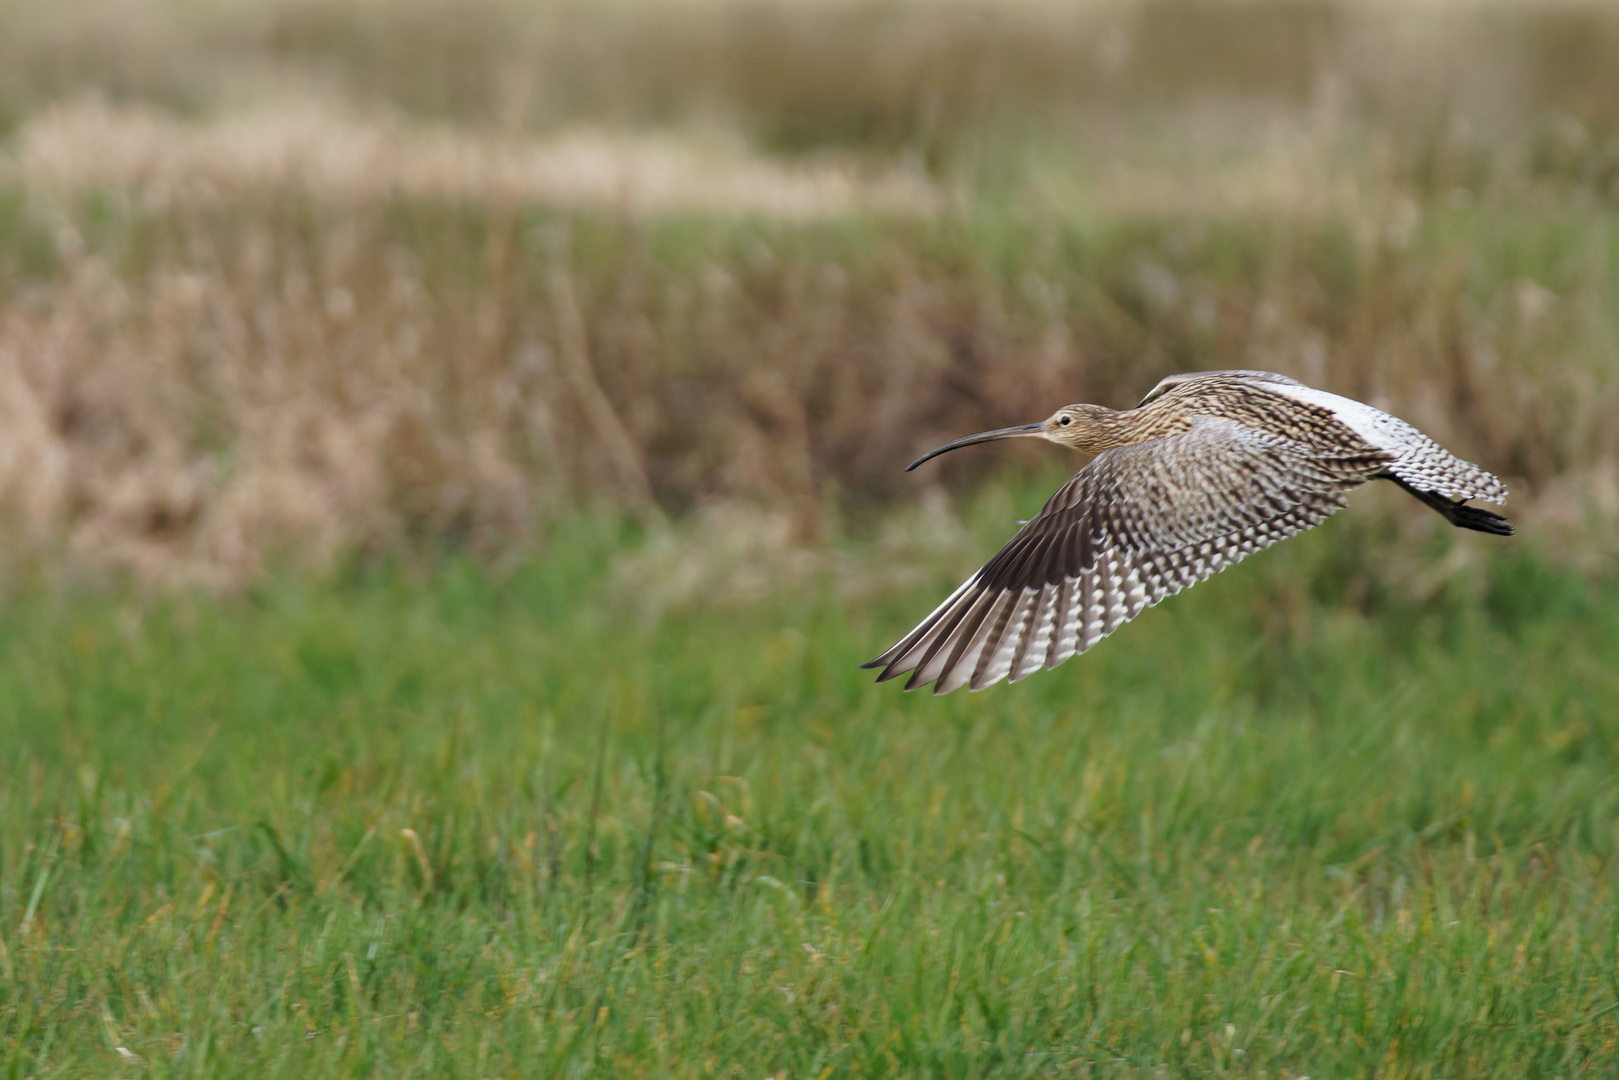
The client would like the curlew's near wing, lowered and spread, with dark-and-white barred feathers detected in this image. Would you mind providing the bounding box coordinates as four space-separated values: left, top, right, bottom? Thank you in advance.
866 418 1389 693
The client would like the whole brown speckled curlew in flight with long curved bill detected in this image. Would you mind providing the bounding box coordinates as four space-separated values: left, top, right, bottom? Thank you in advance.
866 371 1512 693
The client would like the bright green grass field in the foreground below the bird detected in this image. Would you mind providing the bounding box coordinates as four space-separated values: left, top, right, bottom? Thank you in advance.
0 499 1619 1078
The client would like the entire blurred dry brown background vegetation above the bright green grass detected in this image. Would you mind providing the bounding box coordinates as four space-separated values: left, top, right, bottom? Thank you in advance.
0 3 1619 592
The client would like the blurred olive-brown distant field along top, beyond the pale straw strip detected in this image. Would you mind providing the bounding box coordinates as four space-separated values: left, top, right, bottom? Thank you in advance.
0 0 1619 181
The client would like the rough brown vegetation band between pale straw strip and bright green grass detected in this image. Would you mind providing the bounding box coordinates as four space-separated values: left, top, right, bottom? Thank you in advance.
0 196 1619 583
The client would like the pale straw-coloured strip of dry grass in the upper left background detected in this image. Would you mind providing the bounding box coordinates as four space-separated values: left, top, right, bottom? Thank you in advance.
8 100 939 220
